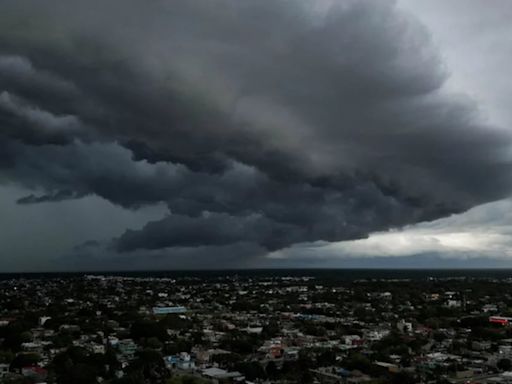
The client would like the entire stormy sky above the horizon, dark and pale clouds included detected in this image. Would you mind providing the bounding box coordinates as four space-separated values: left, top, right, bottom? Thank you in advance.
0 0 512 272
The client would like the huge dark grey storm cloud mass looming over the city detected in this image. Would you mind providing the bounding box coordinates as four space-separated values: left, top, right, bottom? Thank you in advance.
0 0 511 251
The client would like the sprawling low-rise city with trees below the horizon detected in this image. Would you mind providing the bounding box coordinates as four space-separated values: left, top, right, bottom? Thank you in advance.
0 271 512 384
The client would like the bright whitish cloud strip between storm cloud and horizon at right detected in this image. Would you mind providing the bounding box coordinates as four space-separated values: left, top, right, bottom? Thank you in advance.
269 199 512 268
